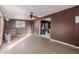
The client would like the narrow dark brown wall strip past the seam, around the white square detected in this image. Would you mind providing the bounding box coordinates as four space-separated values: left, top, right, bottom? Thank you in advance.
74 6 79 46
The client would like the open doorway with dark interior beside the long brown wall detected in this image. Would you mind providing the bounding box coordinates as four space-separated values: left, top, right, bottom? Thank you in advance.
40 18 51 38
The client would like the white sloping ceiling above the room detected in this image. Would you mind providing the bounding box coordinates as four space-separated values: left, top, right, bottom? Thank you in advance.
0 5 75 20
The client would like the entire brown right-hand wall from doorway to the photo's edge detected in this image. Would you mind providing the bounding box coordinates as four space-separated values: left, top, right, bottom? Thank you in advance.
45 6 79 46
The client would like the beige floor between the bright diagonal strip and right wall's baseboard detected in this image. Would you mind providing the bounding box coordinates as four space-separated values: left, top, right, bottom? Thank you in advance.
0 35 79 54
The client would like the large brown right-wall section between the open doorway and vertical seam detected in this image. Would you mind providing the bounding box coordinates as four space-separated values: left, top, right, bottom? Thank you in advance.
51 9 74 44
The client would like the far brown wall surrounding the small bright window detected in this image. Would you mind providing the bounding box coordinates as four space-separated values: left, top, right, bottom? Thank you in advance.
5 19 32 35
